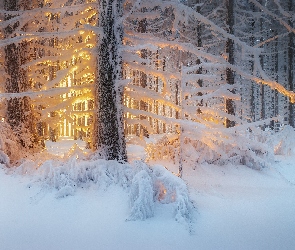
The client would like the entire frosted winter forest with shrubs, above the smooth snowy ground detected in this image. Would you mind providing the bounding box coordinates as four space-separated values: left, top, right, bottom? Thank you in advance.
0 0 295 249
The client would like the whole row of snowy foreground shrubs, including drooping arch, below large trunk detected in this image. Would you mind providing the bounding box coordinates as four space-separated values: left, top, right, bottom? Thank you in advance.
15 153 194 228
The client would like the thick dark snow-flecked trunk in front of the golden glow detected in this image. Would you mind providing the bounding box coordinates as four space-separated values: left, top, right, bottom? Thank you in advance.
93 0 127 161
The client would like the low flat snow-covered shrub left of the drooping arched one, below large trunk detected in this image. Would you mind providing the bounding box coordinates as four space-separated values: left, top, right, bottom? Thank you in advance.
34 157 132 190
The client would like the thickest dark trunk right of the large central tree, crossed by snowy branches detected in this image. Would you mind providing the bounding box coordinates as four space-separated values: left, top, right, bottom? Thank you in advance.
225 0 235 128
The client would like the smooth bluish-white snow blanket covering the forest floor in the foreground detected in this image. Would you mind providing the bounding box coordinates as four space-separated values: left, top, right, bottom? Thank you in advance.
0 141 295 250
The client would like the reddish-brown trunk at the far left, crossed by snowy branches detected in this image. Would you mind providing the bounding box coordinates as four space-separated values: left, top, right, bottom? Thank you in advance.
4 0 39 148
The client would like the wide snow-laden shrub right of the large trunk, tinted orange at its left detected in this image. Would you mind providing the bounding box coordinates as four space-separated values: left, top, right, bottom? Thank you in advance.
147 126 273 169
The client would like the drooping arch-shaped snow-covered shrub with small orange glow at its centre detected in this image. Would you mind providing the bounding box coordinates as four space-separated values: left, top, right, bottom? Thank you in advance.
129 161 195 228
